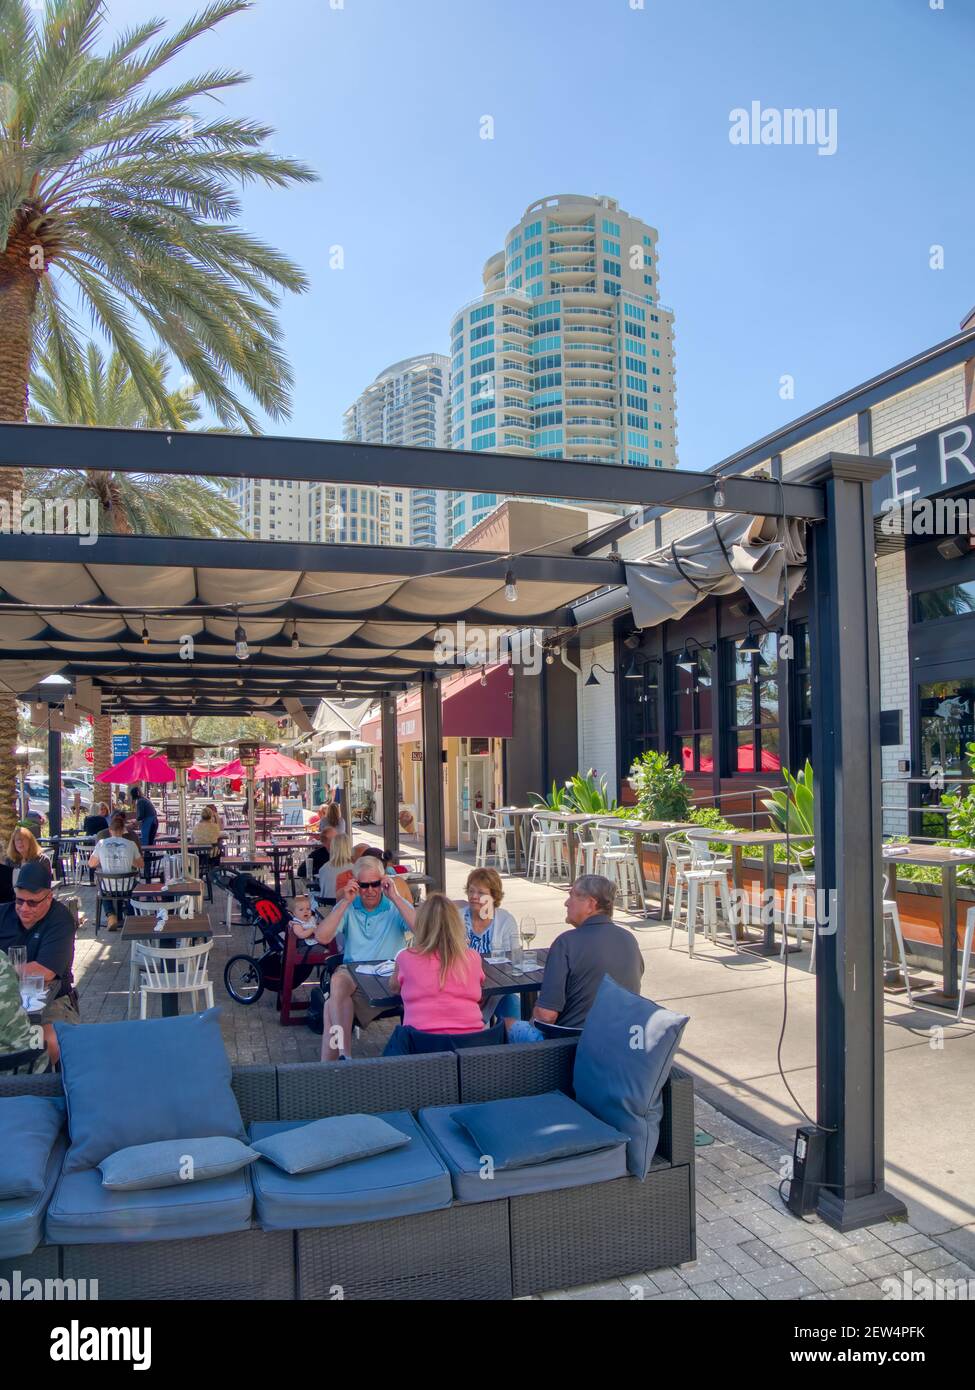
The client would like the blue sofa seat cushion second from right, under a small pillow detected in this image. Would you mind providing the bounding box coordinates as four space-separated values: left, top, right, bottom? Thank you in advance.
250 1111 451 1230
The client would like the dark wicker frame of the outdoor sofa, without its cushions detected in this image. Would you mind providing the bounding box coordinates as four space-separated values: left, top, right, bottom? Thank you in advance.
0 1040 694 1300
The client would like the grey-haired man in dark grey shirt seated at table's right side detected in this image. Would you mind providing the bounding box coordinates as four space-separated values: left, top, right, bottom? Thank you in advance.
506 873 643 1043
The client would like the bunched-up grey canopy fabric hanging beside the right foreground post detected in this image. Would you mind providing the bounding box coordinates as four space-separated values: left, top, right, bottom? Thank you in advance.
626 513 805 627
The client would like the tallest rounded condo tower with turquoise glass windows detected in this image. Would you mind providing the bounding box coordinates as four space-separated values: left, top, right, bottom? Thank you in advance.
448 195 677 543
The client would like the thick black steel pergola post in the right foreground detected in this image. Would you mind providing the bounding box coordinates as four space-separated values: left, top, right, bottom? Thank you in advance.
801 453 905 1230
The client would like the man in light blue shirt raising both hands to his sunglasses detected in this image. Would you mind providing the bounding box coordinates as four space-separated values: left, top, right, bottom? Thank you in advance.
314 855 416 1062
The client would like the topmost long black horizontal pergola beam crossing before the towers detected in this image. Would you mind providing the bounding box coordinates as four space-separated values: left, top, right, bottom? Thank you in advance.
0 424 822 522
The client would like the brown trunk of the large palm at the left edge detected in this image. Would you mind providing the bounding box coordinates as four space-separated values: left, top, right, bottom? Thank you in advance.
0 261 38 847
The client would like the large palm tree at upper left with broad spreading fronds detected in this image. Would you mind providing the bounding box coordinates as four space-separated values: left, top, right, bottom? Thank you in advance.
0 0 314 840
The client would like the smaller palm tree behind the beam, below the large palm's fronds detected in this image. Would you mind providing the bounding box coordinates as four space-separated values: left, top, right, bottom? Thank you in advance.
25 343 243 537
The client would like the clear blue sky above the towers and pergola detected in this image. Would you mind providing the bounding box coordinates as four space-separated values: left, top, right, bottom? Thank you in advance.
102 0 975 468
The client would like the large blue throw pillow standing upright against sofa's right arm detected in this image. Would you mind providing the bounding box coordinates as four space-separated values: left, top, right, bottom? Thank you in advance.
572 974 687 1179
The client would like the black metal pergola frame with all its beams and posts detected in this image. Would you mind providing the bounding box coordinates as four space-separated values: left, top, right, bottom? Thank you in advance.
0 424 905 1230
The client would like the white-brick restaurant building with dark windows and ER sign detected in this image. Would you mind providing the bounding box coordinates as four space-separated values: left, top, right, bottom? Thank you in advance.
569 317 975 834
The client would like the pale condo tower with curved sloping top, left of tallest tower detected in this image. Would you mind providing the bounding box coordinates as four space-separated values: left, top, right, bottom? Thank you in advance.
335 353 449 545
